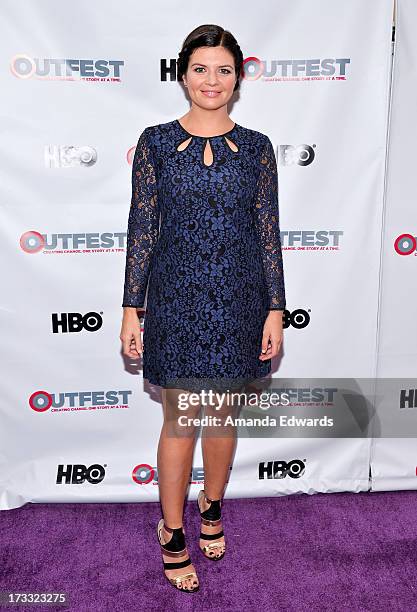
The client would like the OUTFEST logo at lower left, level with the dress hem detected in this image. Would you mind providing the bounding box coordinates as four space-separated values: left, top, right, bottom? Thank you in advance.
29 389 132 412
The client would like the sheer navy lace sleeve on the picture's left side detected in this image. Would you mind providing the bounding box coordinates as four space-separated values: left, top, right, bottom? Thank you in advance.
122 128 159 308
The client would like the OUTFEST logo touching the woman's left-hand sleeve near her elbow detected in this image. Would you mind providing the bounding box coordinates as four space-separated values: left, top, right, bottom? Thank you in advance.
19 230 127 255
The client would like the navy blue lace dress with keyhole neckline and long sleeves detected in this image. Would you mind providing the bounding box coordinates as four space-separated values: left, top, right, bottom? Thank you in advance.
122 120 286 390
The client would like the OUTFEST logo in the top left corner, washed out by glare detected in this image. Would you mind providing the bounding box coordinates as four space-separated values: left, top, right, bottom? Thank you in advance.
10 53 124 83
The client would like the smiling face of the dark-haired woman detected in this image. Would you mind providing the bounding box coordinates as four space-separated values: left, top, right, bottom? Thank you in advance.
183 47 237 109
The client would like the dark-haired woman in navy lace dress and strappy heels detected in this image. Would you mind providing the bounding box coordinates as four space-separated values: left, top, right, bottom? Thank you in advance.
120 25 286 592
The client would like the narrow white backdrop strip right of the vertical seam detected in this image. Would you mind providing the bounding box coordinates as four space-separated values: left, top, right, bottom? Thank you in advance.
371 0 417 491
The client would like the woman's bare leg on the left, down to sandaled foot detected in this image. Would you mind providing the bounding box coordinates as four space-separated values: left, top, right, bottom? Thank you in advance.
157 389 199 589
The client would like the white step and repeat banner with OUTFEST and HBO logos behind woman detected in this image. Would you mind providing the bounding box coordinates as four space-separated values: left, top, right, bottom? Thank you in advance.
0 0 400 509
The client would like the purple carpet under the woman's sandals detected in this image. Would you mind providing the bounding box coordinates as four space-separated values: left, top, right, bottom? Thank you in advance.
0 491 417 612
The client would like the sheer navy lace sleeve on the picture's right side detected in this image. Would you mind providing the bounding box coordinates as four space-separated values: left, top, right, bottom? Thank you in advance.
255 137 286 310
